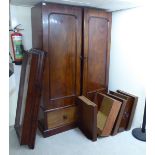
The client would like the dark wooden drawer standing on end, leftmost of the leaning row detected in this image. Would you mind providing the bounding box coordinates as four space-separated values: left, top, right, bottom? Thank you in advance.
76 96 97 141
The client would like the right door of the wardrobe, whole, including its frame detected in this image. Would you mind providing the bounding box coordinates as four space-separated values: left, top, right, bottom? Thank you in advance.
82 8 111 100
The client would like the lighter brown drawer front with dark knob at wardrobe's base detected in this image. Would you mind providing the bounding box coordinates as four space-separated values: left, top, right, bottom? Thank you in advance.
47 106 77 129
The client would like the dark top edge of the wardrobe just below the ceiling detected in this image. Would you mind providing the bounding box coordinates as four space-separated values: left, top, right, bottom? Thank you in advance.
32 1 112 13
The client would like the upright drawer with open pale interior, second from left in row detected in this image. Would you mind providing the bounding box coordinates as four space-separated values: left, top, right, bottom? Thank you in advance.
97 94 122 136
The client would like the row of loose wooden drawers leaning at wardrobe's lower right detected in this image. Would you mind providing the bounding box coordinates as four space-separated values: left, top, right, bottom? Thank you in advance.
77 90 138 141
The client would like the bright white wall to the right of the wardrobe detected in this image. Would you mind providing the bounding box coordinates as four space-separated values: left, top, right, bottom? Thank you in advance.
109 7 150 127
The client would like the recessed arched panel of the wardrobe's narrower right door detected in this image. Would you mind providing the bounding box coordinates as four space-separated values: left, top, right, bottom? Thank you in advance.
87 17 108 91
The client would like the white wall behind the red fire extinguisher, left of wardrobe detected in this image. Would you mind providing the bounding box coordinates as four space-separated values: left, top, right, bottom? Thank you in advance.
9 5 32 126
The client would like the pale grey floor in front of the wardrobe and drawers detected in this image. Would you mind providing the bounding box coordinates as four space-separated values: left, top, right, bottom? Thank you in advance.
9 127 146 155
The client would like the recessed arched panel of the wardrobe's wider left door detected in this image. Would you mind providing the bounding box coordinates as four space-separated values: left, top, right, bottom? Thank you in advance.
49 14 76 100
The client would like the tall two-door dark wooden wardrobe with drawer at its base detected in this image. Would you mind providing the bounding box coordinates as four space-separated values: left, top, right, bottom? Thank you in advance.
32 2 111 137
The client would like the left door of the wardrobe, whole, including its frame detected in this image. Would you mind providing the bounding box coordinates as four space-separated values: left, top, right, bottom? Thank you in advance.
43 3 82 109
